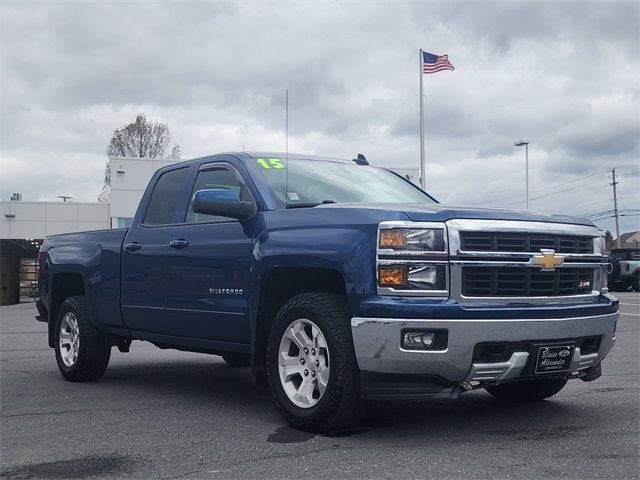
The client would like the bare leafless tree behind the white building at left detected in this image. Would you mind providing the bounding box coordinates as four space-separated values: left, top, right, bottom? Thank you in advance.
98 113 180 202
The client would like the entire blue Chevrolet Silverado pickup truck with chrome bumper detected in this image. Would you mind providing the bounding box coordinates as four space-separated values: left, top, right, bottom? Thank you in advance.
36 152 618 431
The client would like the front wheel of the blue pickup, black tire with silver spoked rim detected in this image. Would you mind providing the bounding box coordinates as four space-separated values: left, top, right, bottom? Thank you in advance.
267 293 363 432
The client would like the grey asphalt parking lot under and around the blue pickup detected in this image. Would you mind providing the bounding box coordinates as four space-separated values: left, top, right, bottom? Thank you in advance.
0 293 640 480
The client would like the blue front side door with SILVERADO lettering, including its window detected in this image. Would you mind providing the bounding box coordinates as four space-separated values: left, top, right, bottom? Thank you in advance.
164 161 254 343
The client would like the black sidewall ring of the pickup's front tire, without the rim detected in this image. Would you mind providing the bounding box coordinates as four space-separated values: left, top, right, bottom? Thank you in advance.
267 306 340 419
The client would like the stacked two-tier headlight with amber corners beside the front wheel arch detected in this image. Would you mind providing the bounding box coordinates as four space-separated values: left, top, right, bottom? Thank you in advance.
377 222 449 297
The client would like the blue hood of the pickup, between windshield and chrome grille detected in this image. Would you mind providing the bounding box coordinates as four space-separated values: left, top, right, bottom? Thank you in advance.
316 203 594 227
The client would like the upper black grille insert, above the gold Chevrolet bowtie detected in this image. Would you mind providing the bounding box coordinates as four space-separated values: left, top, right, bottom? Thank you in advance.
460 231 593 254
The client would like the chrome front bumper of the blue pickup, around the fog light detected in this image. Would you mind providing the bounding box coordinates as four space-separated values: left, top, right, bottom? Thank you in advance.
351 313 618 383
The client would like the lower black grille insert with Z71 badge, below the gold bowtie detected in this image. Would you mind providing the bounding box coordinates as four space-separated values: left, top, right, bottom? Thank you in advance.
462 266 594 297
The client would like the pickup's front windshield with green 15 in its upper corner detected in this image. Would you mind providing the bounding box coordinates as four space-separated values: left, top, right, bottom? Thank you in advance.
255 158 436 208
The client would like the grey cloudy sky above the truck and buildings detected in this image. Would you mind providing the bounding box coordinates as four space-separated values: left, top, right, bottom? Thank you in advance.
0 0 640 232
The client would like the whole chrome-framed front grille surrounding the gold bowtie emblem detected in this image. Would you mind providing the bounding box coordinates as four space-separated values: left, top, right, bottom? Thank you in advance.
446 220 606 304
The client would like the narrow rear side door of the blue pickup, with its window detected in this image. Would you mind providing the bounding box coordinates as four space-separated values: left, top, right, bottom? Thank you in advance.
121 167 189 332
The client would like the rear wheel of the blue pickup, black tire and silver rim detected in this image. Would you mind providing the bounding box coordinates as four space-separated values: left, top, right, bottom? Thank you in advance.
55 297 111 382
